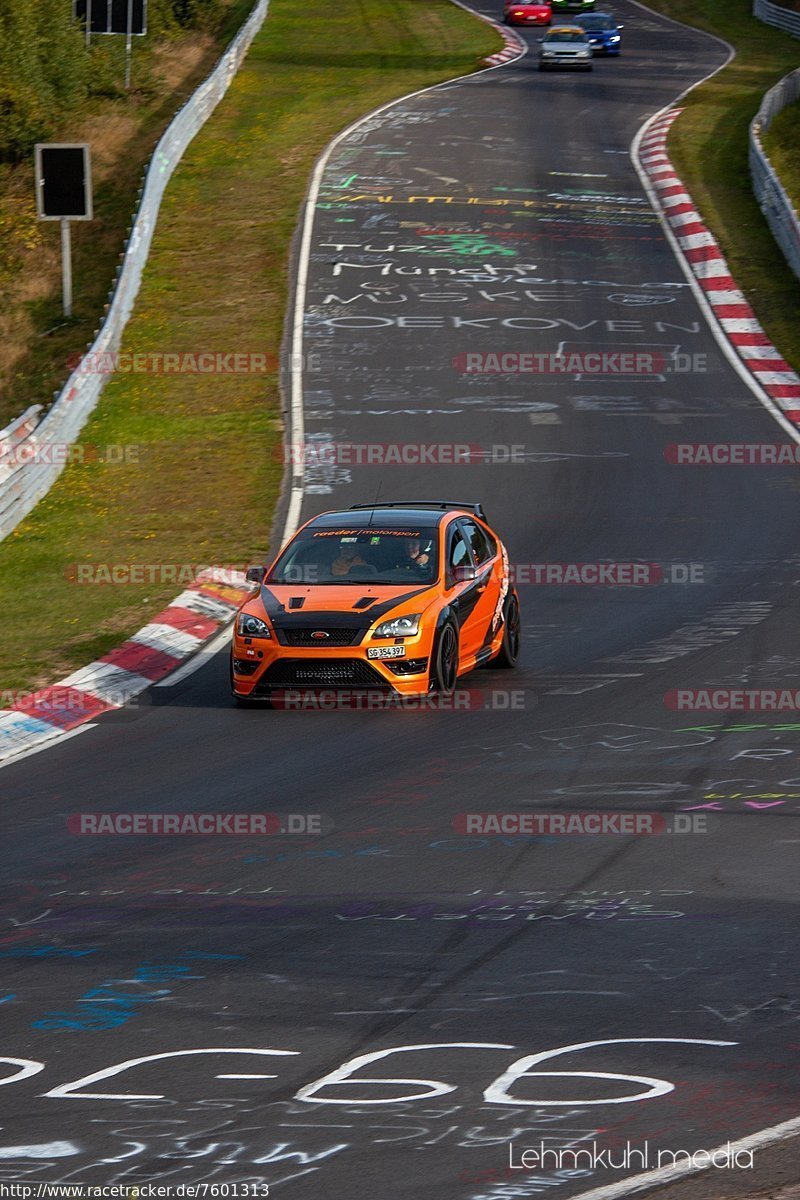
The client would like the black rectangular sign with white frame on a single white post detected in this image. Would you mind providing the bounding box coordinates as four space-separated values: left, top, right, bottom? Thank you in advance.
35 142 92 317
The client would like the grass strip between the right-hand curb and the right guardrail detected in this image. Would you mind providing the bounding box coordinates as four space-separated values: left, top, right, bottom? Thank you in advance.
646 0 800 368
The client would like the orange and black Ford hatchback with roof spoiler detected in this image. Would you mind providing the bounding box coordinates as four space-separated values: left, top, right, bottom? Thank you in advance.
230 500 519 702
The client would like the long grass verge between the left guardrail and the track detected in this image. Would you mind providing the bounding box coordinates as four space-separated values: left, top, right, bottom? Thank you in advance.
0 0 503 689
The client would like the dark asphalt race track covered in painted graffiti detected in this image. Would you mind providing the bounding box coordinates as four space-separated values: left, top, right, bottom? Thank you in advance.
0 0 800 1200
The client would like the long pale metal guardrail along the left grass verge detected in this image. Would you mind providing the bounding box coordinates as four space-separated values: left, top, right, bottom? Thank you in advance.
0 0 269 541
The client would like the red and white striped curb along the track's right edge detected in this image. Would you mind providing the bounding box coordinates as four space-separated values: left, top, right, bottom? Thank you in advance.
638 108 800 425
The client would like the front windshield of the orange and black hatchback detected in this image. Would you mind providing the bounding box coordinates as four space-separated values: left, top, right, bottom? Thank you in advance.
264 524 438 586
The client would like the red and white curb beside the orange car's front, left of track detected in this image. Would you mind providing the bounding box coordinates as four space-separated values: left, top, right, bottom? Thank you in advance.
0 568 252 764
